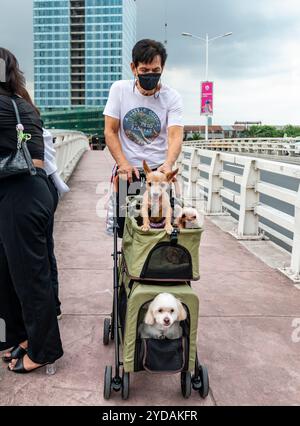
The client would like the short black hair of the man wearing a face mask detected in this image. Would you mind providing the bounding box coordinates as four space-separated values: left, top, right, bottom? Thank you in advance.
132 39 168 67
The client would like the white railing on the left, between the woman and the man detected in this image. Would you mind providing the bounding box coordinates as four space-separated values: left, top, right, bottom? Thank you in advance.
50 129 89 182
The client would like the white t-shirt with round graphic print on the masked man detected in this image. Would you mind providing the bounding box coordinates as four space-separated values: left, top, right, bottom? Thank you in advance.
103 80 183 168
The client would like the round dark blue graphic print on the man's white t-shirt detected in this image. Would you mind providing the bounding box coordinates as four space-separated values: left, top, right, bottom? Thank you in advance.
123 108 161 146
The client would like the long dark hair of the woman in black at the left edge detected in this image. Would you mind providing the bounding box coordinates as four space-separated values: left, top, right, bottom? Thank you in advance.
0 47 40 115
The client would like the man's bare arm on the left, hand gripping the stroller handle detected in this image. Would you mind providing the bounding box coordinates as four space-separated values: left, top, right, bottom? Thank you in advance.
104 115 139 181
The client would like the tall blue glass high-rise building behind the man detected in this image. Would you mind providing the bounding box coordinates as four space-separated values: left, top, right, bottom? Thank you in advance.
34 0 136 111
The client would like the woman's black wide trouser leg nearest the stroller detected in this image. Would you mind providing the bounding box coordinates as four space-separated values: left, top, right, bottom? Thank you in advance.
1 172 63 364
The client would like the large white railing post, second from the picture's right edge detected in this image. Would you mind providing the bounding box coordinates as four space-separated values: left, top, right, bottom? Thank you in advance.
237 160 260 237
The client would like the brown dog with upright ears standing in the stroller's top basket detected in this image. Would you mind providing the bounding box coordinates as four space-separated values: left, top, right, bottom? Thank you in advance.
141 160 178 234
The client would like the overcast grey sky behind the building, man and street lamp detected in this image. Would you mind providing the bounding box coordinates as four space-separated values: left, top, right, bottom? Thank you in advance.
0 0 300 124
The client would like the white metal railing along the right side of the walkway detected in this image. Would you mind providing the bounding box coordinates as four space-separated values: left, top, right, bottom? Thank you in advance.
177 145 300 281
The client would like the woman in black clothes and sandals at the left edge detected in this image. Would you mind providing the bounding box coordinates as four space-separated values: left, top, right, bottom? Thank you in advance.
0 48 63 373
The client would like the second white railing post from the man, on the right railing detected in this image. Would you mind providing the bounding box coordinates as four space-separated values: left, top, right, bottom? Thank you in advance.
205 152 223 214
